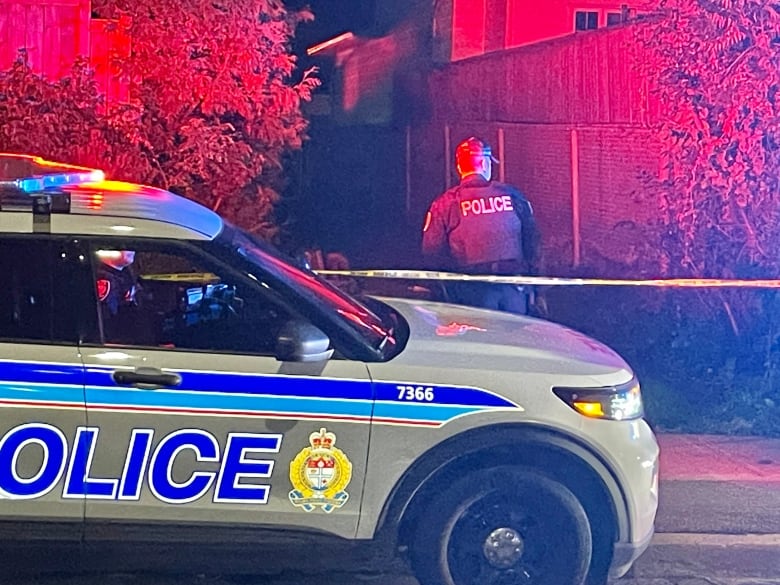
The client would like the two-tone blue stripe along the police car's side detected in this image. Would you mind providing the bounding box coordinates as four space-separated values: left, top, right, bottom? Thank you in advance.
0 362 520 425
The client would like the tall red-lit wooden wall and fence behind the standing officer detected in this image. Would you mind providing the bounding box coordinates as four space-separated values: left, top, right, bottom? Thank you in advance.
410 25 660 270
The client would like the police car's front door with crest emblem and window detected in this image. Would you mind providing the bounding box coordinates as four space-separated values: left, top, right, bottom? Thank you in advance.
82 240 372 540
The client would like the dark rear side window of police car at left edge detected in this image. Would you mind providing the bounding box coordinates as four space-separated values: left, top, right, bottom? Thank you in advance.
0 237 83 342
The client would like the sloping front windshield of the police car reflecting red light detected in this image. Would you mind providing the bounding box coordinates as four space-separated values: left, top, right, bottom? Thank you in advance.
218 224 393 350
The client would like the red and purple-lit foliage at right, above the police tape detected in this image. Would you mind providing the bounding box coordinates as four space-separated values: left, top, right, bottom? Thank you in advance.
640 0 780 276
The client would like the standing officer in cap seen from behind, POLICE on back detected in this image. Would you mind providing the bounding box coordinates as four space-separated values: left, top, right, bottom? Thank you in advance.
422 137 539 314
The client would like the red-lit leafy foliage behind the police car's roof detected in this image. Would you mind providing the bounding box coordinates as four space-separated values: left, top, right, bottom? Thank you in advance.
0 0 318 236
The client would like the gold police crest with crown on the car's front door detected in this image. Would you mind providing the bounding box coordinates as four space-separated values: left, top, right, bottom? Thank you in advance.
290 428 352 514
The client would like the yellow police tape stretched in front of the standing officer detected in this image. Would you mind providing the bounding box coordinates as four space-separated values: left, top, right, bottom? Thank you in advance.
316 270 780 288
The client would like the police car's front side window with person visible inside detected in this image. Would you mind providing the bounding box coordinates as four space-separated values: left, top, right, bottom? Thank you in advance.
91 243 291 355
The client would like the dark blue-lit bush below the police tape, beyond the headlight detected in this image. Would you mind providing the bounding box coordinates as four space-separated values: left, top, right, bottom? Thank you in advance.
547 274 780 436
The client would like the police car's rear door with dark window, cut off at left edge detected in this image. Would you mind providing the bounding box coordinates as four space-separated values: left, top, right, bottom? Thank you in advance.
0 234 91 540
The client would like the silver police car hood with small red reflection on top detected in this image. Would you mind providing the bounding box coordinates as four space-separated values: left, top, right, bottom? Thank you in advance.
381 298 632 384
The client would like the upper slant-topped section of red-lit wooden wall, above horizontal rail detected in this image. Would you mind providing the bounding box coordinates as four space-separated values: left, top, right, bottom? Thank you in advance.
431 24 658 125
